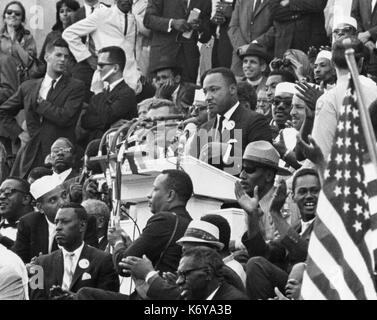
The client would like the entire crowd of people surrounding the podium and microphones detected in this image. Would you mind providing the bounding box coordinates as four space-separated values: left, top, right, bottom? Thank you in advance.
0 0 377 300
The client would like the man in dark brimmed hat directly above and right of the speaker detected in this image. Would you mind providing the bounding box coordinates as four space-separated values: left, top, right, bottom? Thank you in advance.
239 43 271 94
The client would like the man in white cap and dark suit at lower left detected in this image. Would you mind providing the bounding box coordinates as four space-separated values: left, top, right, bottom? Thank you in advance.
12 176 98 263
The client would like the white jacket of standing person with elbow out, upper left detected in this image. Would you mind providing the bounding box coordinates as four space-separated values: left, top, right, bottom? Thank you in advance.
63 5 140 90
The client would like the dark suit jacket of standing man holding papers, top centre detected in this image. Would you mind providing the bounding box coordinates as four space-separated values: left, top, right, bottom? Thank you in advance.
144 0 212 80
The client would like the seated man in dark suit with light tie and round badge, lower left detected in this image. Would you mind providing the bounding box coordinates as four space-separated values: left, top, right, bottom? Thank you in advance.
30 203 119 300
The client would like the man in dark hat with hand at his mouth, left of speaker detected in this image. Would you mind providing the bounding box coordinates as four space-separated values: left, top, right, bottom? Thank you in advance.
152 58 196 113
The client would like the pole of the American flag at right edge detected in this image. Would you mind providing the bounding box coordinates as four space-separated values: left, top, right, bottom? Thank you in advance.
343 45 377 168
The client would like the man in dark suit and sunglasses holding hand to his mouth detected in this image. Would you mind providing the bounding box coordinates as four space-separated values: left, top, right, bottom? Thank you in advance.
81 46 137 141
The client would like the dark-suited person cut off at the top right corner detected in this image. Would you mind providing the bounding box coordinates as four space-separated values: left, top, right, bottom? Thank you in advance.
351 0 377 76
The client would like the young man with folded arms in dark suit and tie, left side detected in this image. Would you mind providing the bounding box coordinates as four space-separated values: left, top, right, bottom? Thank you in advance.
0 39 84 178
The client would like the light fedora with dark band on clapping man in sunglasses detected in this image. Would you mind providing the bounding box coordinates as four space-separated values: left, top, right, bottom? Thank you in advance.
242 141 291 176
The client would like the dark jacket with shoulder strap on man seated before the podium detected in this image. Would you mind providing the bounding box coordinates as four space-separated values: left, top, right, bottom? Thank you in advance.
113 207 192 272
